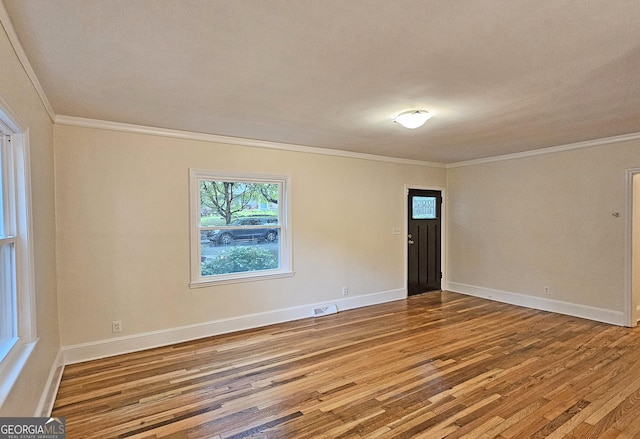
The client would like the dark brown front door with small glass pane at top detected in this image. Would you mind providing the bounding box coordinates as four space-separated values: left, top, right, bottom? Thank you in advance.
407 189 442 295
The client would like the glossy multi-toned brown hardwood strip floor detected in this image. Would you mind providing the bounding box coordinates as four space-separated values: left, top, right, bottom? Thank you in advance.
53 292 640 439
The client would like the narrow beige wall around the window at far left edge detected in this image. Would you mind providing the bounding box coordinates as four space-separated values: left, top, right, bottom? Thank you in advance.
0 24 60 416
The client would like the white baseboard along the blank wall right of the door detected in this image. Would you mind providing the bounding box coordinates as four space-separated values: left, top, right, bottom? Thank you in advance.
446 282 625 326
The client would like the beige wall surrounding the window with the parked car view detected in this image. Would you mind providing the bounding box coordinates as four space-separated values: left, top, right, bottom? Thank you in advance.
55 125 445 345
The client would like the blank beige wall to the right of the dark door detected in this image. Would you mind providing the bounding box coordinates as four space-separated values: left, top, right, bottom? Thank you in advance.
447 141 640 312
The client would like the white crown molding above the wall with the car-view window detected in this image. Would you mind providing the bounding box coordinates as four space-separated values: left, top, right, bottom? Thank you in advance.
54 115 445 168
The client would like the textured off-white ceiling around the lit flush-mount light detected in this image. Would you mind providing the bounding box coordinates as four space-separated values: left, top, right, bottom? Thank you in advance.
4 0 640 163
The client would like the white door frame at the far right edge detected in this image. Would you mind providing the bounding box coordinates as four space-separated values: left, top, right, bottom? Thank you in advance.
624 168 640 327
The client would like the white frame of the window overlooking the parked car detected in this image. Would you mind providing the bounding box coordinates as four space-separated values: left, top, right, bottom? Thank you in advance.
189 169 294 288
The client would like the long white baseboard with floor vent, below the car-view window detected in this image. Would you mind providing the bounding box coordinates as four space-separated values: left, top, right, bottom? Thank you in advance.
62 289 407 364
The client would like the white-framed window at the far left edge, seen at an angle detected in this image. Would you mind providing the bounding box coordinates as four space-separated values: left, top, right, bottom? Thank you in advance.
0 98 38 407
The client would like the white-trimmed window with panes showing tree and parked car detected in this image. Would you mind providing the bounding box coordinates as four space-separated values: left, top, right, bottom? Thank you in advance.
190 169 292 287
